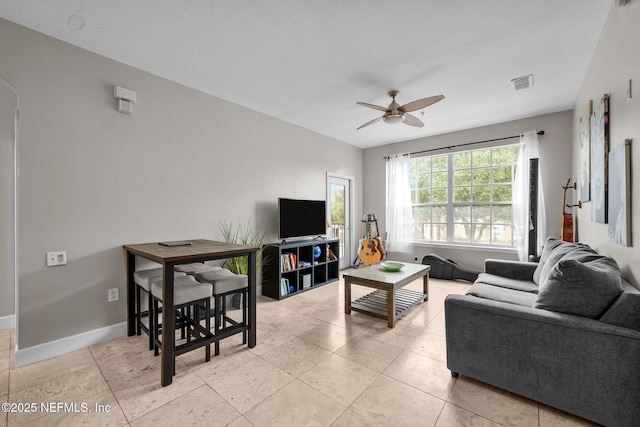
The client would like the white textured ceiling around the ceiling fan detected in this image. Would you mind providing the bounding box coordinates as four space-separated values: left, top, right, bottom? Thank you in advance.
0 0 612 147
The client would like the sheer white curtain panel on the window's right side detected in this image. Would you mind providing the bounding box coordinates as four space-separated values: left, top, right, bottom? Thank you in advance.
512 131 547 261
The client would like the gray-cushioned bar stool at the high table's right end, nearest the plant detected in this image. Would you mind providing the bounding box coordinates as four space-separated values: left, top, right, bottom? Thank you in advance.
195 268 249 356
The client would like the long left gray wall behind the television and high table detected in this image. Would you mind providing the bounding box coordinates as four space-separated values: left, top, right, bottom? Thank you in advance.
0 20 362 349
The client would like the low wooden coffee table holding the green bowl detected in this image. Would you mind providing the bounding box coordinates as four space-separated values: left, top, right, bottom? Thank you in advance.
342 263 431 328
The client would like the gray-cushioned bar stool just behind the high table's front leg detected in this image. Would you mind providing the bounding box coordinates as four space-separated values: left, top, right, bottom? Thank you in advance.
151 276 212 364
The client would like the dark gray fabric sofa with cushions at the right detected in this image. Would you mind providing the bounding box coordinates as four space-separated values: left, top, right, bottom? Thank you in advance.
445 239 640 426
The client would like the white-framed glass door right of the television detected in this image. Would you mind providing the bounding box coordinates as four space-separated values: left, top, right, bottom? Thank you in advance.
327 173 353 270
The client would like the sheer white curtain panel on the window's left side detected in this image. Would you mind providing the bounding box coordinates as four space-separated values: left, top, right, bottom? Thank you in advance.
386 154 413 252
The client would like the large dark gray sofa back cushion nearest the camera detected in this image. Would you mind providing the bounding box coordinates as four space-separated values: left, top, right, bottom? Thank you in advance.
534 256 622 319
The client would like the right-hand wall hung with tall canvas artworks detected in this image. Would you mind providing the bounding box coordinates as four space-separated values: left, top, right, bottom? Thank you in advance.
573 1 640 287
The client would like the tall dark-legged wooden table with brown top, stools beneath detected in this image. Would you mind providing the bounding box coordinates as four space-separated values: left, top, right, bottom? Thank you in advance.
123 239 260 386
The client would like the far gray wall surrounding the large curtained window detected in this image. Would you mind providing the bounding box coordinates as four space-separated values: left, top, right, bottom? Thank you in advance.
363 110 572 271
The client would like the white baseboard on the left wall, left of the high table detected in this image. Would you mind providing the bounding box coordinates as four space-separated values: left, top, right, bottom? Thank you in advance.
15 319 127 367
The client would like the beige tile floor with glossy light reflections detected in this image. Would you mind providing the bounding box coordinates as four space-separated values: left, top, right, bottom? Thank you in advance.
0 279 591 427
